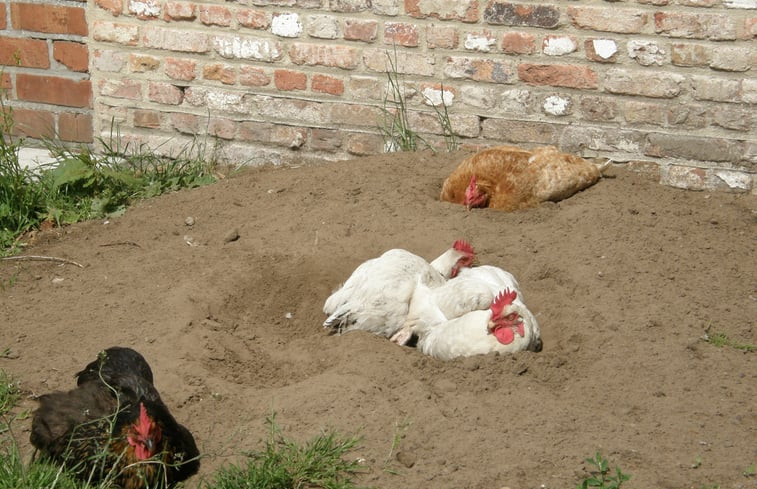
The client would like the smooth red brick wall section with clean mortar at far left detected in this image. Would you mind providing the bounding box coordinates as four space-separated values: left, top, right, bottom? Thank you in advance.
0 0 92 143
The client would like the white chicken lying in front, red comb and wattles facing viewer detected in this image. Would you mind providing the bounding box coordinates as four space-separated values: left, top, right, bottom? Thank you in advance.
412 284 542 360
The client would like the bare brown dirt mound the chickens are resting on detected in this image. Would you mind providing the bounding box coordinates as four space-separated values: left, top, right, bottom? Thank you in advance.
0 152 757 489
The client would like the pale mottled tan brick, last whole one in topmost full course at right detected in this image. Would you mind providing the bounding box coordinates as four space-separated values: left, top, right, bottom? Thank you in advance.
654 12 736 41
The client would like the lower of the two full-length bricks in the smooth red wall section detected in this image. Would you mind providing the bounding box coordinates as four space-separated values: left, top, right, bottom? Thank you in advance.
16 73 92 108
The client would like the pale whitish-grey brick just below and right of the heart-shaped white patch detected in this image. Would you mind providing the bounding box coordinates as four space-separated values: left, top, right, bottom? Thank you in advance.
604 68 686 98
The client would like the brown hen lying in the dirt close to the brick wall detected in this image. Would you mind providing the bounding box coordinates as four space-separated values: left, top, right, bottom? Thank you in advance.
440 146 610 211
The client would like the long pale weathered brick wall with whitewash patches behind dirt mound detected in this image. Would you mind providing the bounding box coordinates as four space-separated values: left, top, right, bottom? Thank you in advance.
5 0 757 192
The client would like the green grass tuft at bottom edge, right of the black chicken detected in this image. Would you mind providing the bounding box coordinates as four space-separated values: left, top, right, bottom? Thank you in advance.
204 415 361 489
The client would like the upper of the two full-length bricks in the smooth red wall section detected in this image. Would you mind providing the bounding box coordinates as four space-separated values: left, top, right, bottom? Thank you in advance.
11 2 88 36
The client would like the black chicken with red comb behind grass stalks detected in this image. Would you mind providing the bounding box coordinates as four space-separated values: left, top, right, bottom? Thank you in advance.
30 347 200 489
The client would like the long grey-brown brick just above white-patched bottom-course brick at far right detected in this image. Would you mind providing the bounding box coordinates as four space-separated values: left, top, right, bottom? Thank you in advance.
644 133 744 161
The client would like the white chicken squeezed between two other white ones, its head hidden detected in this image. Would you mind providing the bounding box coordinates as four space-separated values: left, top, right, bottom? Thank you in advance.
391 265 525 345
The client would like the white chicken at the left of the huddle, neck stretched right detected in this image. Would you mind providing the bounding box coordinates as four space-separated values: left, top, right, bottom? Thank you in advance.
323 240 475 338
